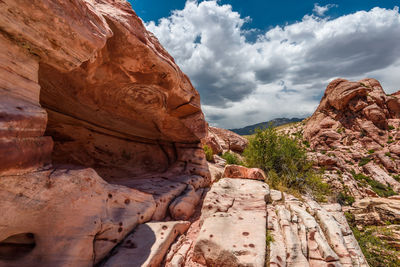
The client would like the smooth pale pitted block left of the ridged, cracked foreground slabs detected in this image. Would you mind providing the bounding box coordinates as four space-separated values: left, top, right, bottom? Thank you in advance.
193 178 269 267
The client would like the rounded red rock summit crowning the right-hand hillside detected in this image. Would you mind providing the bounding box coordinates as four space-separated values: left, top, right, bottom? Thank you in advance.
304 79 400 151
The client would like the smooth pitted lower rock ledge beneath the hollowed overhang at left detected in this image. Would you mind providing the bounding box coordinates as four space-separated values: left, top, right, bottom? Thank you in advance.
0 168 156 267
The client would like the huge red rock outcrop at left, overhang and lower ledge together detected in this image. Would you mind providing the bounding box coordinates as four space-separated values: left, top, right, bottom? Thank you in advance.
0 0 210 266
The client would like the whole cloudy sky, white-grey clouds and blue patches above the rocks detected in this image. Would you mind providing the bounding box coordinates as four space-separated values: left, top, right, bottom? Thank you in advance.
127 0 400 128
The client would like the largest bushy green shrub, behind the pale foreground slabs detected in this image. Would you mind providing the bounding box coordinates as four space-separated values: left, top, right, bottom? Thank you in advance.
243 127 330 201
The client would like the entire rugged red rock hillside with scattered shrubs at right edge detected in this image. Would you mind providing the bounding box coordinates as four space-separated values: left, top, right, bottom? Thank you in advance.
283 79 400 264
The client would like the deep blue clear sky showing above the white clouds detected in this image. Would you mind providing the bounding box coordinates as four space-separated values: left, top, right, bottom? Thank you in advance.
129 0 400 30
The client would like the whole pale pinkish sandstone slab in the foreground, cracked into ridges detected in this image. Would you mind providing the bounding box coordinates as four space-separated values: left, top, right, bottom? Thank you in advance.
165 168 368 267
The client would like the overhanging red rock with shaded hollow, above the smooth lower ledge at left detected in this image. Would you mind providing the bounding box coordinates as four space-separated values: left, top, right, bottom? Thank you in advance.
0 0 206 178
